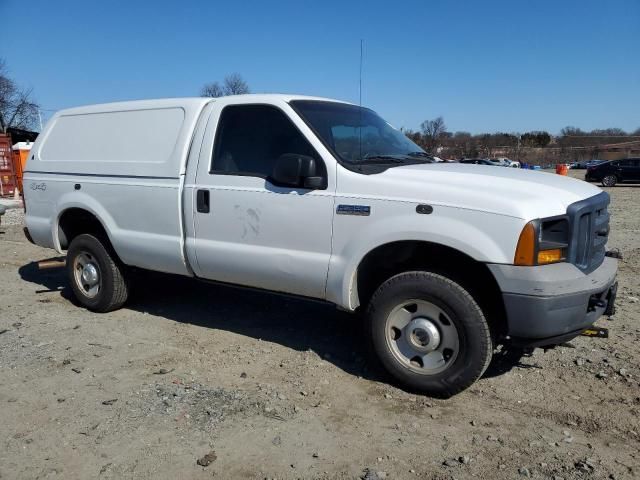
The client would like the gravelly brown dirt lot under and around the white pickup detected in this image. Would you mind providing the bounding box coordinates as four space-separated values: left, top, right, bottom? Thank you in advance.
0 171 640 480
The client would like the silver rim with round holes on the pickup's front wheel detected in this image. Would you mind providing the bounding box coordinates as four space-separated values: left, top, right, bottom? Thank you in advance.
385 300 460 375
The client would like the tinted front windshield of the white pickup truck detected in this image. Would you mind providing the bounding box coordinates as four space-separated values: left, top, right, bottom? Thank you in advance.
291 100 433 166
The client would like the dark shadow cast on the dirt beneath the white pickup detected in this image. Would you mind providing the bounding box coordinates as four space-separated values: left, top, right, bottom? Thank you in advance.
19 262 523 390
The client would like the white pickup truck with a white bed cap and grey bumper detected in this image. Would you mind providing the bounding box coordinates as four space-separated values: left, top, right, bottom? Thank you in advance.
24 95 617 396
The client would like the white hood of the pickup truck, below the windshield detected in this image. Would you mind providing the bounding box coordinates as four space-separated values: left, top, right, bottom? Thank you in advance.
370 163 601 220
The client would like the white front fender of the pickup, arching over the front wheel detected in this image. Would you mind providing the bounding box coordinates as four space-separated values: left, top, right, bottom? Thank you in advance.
327 202 525 310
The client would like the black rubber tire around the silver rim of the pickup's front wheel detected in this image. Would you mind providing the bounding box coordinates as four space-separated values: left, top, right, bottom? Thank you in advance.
365 271 493 397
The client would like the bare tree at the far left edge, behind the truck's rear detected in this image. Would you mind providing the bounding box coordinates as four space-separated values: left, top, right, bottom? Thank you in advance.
0 58 38 133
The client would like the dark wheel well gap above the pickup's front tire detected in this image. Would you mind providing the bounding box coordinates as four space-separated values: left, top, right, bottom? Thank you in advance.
356 241 507 339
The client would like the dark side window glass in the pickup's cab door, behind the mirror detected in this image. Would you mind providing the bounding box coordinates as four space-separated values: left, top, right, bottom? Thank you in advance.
210 105 325 178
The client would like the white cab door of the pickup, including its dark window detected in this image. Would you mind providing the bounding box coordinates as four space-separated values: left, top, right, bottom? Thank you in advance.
190 102 335 298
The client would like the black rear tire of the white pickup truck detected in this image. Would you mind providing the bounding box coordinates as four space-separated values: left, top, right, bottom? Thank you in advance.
67 234 129 313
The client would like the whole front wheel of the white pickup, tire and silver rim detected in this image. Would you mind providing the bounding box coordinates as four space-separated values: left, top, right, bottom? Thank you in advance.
367 272 493 397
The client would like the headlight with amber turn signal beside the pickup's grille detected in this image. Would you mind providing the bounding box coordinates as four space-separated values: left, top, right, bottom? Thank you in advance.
513 216 569 266
